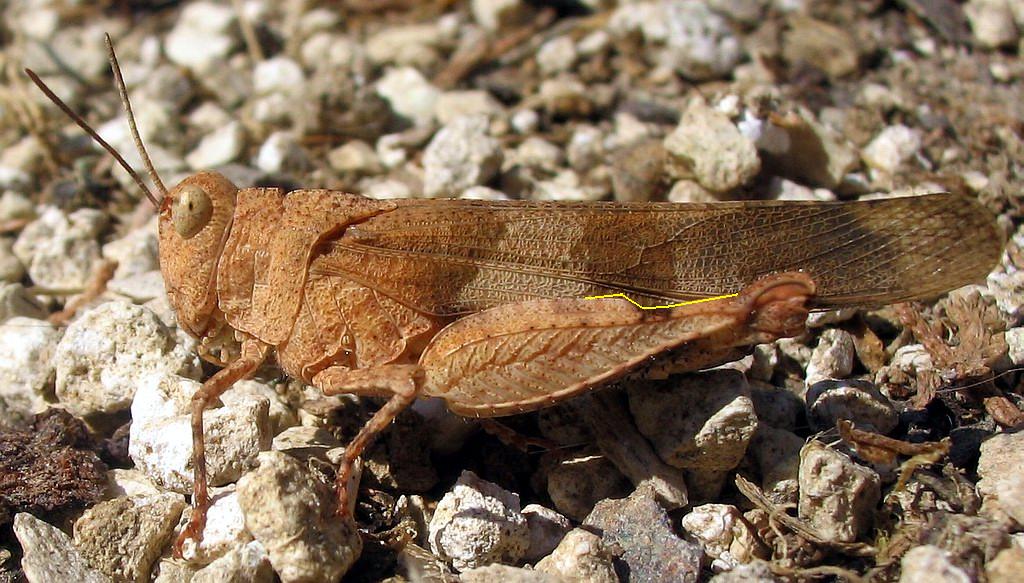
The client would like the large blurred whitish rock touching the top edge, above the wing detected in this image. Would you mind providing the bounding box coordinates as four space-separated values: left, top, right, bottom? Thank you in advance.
608 0 743 81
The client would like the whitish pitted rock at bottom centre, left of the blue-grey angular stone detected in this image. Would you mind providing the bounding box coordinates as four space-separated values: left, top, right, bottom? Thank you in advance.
427 470 529 571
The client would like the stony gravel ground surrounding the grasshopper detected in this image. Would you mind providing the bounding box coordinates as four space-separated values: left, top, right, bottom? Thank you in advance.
0 0 1024 583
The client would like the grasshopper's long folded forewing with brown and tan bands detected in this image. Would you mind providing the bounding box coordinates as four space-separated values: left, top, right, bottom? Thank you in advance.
310 194 1002 315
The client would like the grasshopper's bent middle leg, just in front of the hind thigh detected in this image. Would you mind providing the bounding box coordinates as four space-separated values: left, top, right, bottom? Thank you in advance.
312 365 423 517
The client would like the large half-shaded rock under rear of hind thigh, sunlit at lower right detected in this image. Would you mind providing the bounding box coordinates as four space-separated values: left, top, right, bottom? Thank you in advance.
628 370 758 471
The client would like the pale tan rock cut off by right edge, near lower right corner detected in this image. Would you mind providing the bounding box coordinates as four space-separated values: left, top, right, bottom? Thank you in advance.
977 433 1024 525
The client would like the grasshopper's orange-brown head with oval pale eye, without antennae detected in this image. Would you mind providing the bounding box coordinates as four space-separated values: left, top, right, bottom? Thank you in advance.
160 172 239 338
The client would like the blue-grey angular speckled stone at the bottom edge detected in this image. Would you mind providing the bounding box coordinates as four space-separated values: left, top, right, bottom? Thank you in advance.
584 490 703 582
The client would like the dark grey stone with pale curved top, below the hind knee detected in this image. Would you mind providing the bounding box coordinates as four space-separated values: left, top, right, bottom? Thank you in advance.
806 379 899 434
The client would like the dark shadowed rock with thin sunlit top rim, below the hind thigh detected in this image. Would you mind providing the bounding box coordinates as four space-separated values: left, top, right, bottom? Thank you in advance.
548 451 632 520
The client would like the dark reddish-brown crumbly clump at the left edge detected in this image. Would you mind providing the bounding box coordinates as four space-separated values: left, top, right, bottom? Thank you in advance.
0 409 106 524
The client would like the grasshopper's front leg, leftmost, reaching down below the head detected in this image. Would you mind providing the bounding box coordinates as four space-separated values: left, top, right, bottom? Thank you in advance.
174 338 267 557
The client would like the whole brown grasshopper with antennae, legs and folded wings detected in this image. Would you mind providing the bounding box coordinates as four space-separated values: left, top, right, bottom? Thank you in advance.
29 39 1001 549
